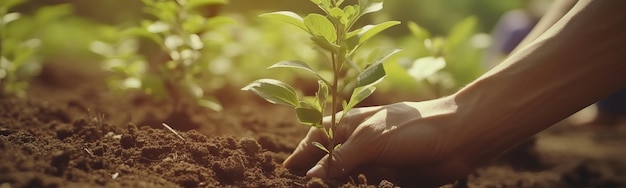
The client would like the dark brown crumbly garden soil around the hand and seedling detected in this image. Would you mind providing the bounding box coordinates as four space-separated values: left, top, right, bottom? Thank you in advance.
0 63 626 188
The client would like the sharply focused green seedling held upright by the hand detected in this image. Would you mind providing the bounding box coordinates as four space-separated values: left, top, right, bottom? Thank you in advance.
242 0 400 175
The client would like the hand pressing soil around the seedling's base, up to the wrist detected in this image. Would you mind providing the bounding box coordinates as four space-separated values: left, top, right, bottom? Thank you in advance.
283 98 472 186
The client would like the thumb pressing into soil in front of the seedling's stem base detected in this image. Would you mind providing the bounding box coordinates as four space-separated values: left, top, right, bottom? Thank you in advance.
306 141 364 178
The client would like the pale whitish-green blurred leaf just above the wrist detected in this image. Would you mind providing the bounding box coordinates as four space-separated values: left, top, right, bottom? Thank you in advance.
408 56 446 81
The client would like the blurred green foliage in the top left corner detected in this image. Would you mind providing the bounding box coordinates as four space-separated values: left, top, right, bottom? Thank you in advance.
0 0 107 96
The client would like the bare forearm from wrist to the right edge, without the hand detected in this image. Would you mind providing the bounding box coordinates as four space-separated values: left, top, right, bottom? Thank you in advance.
453 0 626 162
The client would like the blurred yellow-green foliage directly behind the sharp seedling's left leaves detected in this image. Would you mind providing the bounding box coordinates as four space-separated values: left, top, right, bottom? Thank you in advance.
210 16 321 88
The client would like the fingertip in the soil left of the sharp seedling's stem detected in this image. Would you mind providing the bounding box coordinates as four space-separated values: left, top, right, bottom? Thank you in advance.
283 127 328 170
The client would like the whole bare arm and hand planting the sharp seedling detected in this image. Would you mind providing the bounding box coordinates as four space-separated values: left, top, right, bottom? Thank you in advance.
284 0 626 186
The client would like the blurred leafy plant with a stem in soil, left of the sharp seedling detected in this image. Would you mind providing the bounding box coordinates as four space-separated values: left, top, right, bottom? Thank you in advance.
92 0 233 111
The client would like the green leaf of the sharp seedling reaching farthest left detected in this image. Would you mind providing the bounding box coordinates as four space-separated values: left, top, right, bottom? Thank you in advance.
241 79 298 108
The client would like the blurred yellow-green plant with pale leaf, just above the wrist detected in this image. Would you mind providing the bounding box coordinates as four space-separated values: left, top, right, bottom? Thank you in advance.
400 17 487 97
